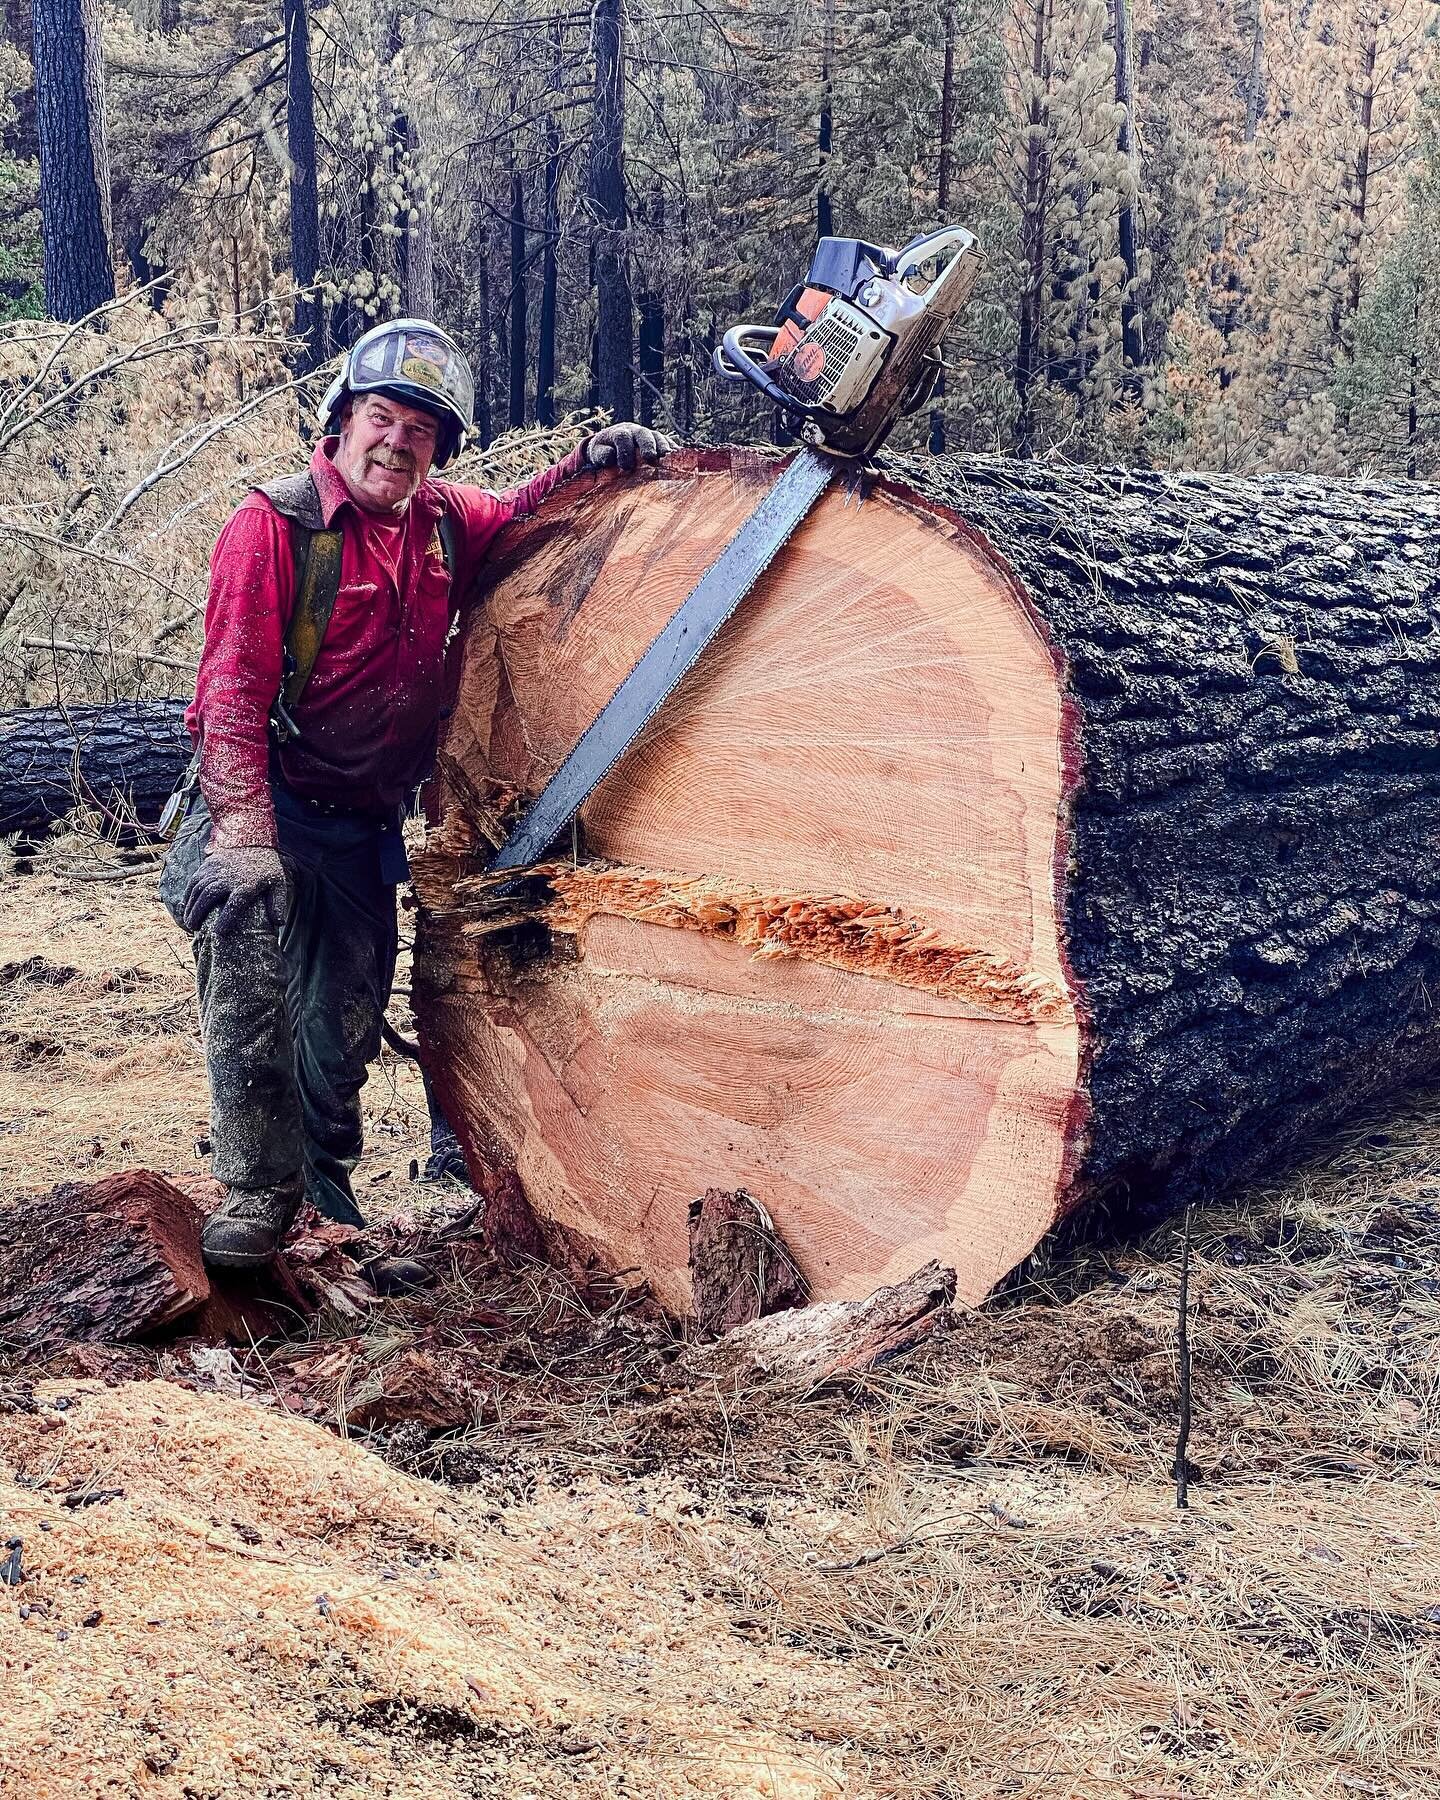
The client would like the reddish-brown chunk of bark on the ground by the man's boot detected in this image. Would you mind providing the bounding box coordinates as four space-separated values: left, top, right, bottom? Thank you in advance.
0 1170 211 1359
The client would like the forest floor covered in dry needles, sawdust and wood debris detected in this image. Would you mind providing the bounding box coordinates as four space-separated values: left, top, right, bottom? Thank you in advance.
0 877 1440 1800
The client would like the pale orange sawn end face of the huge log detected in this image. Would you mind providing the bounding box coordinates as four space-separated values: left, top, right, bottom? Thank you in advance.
416 455 1080 1312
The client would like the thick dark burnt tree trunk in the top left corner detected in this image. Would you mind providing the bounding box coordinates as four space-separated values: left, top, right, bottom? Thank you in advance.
32 0 115 319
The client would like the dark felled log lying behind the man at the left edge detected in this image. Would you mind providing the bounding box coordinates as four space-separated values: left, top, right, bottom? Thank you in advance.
0 700 191 837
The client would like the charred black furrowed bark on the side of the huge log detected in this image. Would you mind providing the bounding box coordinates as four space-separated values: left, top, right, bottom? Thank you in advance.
886 457 1440 1217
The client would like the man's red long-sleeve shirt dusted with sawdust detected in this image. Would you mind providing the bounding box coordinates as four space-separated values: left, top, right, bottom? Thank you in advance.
185 437 585 848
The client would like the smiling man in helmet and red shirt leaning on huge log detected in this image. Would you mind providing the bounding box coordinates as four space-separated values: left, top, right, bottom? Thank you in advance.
160 319 668 1267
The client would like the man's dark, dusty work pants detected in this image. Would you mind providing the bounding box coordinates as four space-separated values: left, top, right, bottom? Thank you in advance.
160 788 398 1224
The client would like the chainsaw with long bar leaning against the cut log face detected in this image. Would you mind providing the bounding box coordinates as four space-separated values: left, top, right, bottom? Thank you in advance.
488 225 979 875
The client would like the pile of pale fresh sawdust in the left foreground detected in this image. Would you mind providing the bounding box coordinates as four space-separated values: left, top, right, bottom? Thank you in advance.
0 1382 866 1800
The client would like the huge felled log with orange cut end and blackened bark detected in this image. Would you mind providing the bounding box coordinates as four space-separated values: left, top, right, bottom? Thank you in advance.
416 452 1440 1310
